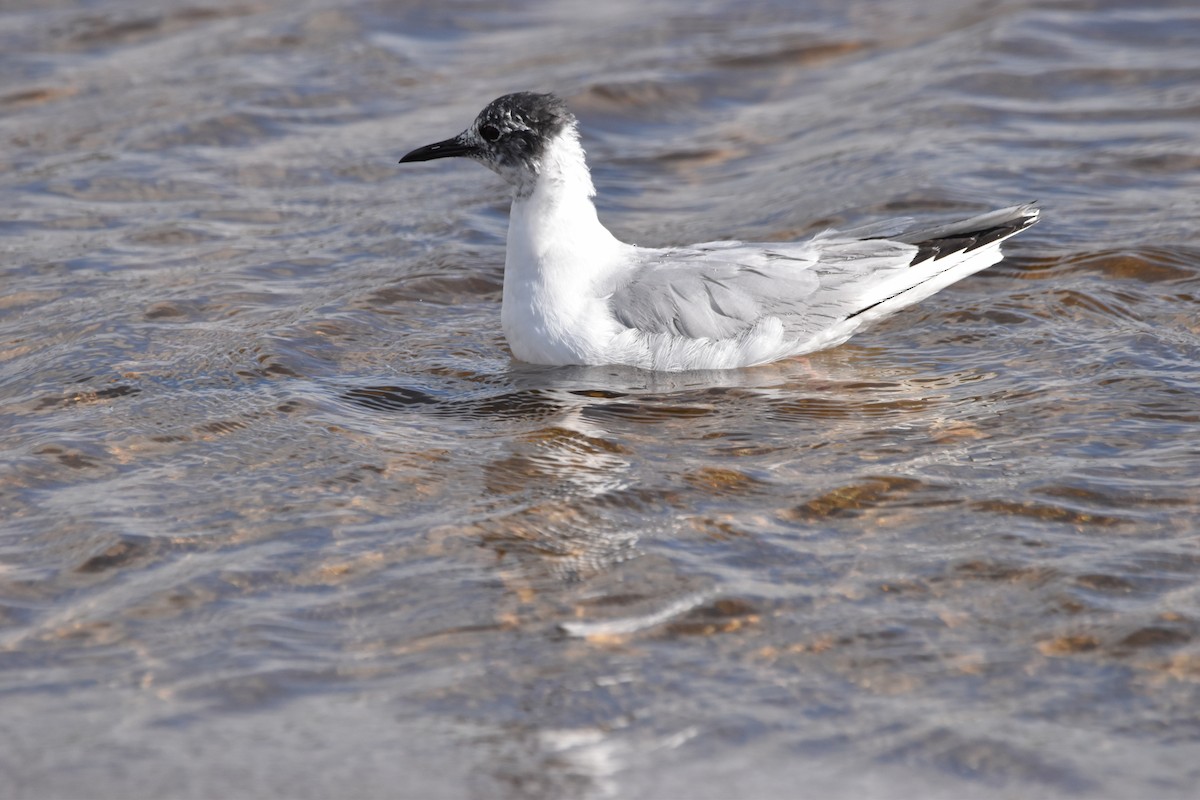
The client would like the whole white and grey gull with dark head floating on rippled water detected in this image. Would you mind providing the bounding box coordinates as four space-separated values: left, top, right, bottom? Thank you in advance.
400 92 1038 372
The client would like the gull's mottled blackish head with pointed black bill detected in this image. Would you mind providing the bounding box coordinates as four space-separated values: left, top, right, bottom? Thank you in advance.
400 91 575 188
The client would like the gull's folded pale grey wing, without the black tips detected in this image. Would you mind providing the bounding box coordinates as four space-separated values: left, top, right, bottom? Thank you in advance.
608 230 917 339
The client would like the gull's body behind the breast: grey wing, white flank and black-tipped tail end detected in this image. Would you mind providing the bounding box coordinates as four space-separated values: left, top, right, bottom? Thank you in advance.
608 205 1038 369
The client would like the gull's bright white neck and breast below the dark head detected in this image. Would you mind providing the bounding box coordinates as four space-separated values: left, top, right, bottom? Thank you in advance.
500 127 629 363
